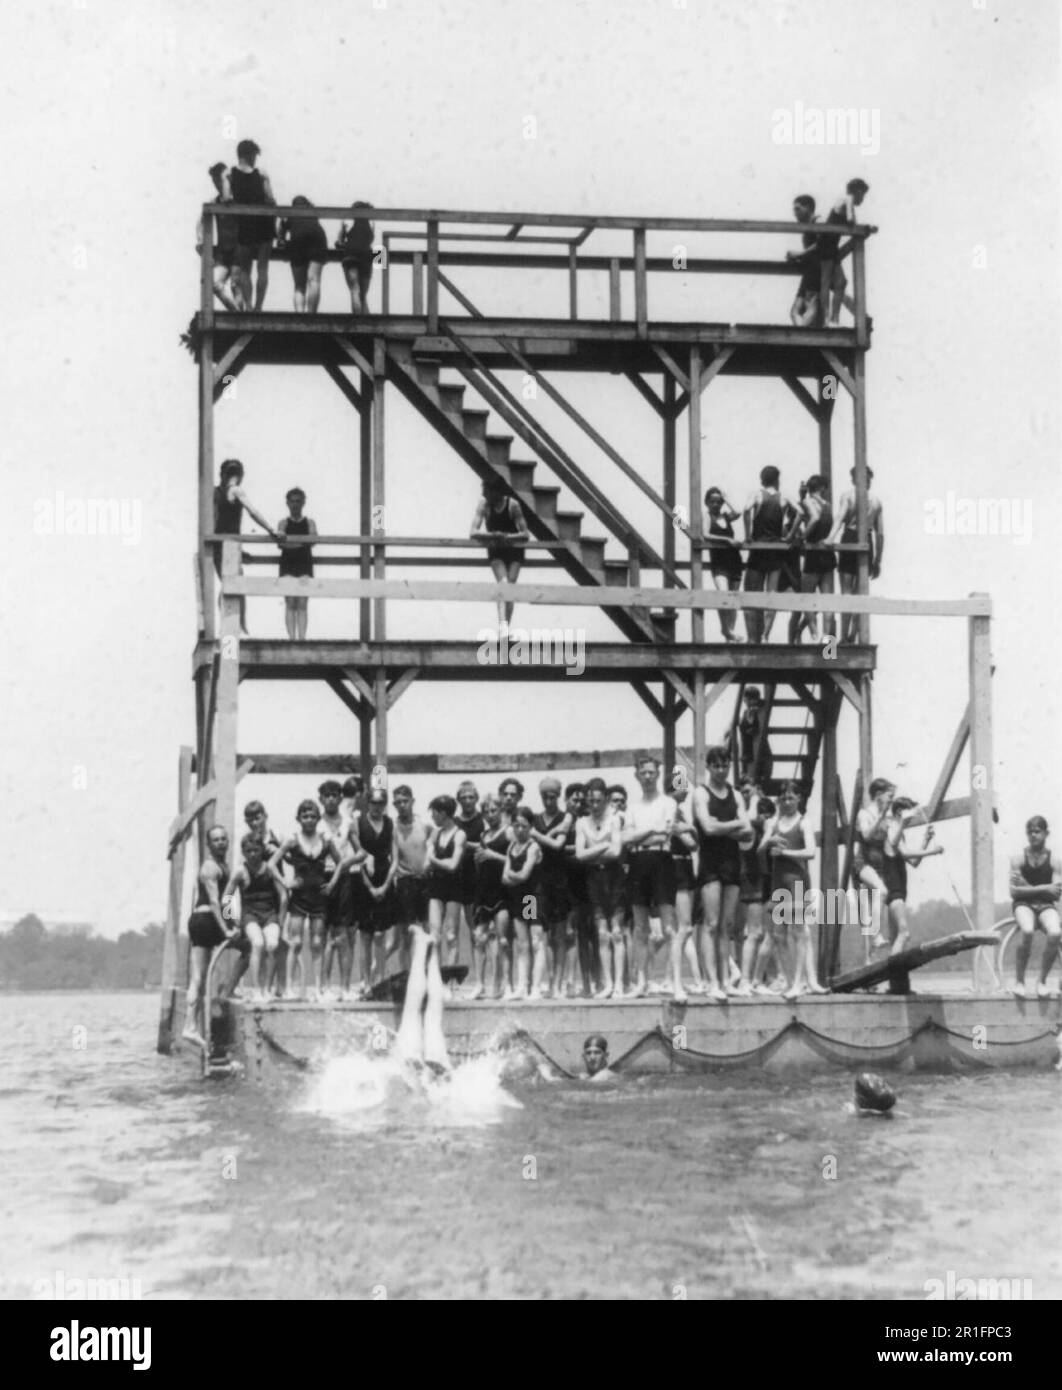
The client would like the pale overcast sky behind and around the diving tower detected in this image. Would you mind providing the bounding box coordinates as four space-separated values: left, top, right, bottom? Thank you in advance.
0 0 1059 934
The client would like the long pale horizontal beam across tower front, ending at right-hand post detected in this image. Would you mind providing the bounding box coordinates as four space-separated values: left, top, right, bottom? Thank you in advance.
224 575 991 617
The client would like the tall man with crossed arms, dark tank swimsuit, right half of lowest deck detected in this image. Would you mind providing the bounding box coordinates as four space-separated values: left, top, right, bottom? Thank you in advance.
694 745 752 1004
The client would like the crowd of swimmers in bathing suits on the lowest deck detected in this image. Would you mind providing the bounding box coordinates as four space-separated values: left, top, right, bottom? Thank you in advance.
188 746 1062 1036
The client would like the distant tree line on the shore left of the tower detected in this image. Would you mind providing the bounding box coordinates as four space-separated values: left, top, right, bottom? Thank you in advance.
0 912 163 990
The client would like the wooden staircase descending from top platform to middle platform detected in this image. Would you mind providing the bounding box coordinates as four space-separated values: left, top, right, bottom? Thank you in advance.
388 343 674 642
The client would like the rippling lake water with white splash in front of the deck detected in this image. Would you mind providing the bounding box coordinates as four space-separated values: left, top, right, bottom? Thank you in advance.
0 994 1062 1298
